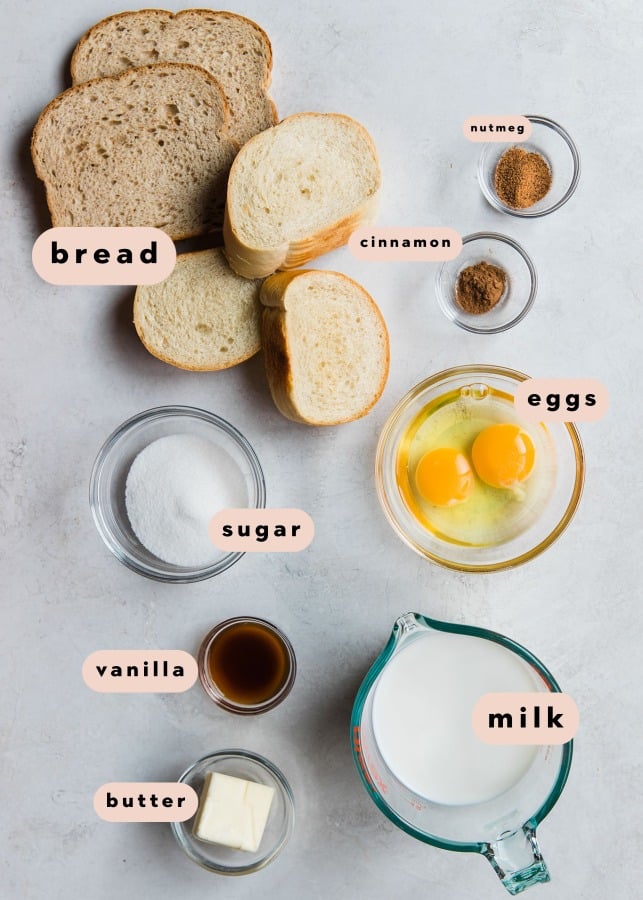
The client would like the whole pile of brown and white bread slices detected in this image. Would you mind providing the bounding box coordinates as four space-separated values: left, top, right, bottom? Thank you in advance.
32 10 389 425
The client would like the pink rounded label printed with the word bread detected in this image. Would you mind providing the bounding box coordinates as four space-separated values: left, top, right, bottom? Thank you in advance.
31 227 176 285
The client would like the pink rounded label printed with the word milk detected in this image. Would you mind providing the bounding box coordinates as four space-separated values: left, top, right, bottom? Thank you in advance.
472 691 579 744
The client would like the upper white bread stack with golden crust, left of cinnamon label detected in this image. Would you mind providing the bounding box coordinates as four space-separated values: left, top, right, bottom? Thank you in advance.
223 113 381 278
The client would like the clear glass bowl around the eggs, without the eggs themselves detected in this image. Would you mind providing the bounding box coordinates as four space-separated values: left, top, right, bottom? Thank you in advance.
375 365 585 572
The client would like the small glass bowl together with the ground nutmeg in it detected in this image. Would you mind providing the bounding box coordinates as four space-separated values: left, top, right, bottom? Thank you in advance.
478 116 580 219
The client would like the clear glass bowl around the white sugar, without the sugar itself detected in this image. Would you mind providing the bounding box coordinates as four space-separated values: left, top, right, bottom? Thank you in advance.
89 406 266 584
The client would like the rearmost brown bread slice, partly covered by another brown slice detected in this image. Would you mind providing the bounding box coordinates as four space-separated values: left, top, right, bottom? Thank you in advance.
71 9 277 146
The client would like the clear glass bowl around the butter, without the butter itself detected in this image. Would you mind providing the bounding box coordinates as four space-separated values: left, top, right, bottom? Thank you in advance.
171 750 295 875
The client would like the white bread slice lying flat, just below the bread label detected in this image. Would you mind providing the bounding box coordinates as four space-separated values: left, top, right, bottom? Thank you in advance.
134 249 261 372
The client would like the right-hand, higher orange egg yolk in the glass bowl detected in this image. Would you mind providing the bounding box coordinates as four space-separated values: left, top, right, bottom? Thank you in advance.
471 423 536 488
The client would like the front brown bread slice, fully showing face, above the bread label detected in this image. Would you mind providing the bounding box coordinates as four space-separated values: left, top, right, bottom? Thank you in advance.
31 63 238 240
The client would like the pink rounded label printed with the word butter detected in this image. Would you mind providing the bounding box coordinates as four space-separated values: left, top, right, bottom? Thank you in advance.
94 781 199 822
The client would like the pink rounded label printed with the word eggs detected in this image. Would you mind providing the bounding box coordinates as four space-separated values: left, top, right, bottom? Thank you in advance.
514 378 609 422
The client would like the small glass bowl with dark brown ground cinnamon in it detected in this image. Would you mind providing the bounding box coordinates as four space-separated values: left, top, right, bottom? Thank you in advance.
436 231 538 334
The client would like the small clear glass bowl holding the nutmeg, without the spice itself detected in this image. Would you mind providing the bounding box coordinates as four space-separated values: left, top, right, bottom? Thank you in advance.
478 116 580 219
